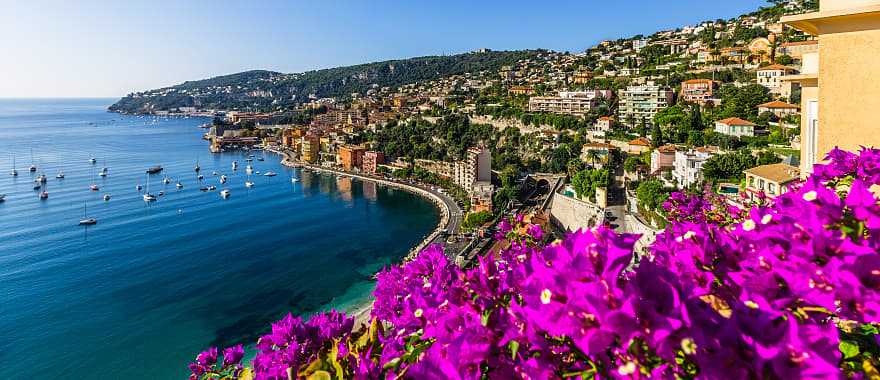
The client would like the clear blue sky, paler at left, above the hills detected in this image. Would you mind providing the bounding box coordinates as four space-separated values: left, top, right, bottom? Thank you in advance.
0 0 766 98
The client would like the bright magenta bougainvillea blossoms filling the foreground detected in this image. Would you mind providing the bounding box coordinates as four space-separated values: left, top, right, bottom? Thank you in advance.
190 149 880 379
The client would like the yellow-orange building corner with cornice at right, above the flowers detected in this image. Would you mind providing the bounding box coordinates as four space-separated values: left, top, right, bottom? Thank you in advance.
782 0 880 175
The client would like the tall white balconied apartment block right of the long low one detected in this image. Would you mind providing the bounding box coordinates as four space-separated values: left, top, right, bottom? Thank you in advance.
618 82 675 127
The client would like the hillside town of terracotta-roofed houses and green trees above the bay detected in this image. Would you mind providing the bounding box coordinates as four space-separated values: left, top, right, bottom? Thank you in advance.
155 0 859 256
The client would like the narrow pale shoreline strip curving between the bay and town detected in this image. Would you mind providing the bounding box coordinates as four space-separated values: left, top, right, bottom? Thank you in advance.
263 147 451 325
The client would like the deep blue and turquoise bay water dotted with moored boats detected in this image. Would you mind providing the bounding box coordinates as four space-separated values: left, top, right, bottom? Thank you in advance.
0 99 439 379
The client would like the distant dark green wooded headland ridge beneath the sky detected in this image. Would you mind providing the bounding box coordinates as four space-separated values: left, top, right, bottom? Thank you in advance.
110 50 537 113
